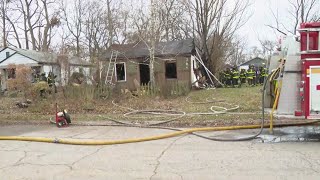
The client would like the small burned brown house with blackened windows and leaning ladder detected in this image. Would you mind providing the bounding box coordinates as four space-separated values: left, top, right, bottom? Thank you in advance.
101 39 197 90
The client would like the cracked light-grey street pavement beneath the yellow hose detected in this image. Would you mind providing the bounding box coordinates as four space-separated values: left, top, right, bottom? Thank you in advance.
0 125 320 180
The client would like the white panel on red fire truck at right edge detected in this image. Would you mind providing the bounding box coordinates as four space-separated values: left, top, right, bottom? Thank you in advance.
310 66 320 114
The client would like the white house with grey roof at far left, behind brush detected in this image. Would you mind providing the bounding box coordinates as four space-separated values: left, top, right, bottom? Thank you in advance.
0 47 91 90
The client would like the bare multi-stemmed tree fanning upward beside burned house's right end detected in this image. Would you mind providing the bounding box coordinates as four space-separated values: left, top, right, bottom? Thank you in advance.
183 0 250 78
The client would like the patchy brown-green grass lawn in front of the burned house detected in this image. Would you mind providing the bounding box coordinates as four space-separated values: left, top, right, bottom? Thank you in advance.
0 86 262 126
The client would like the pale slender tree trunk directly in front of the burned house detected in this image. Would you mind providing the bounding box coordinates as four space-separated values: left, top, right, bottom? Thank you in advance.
149 0 156 87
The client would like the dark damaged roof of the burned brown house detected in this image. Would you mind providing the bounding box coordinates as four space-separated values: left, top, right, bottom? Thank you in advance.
103 39 194 58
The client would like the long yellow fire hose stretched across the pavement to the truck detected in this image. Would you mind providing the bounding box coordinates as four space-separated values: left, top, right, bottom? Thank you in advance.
0 70 319 145
